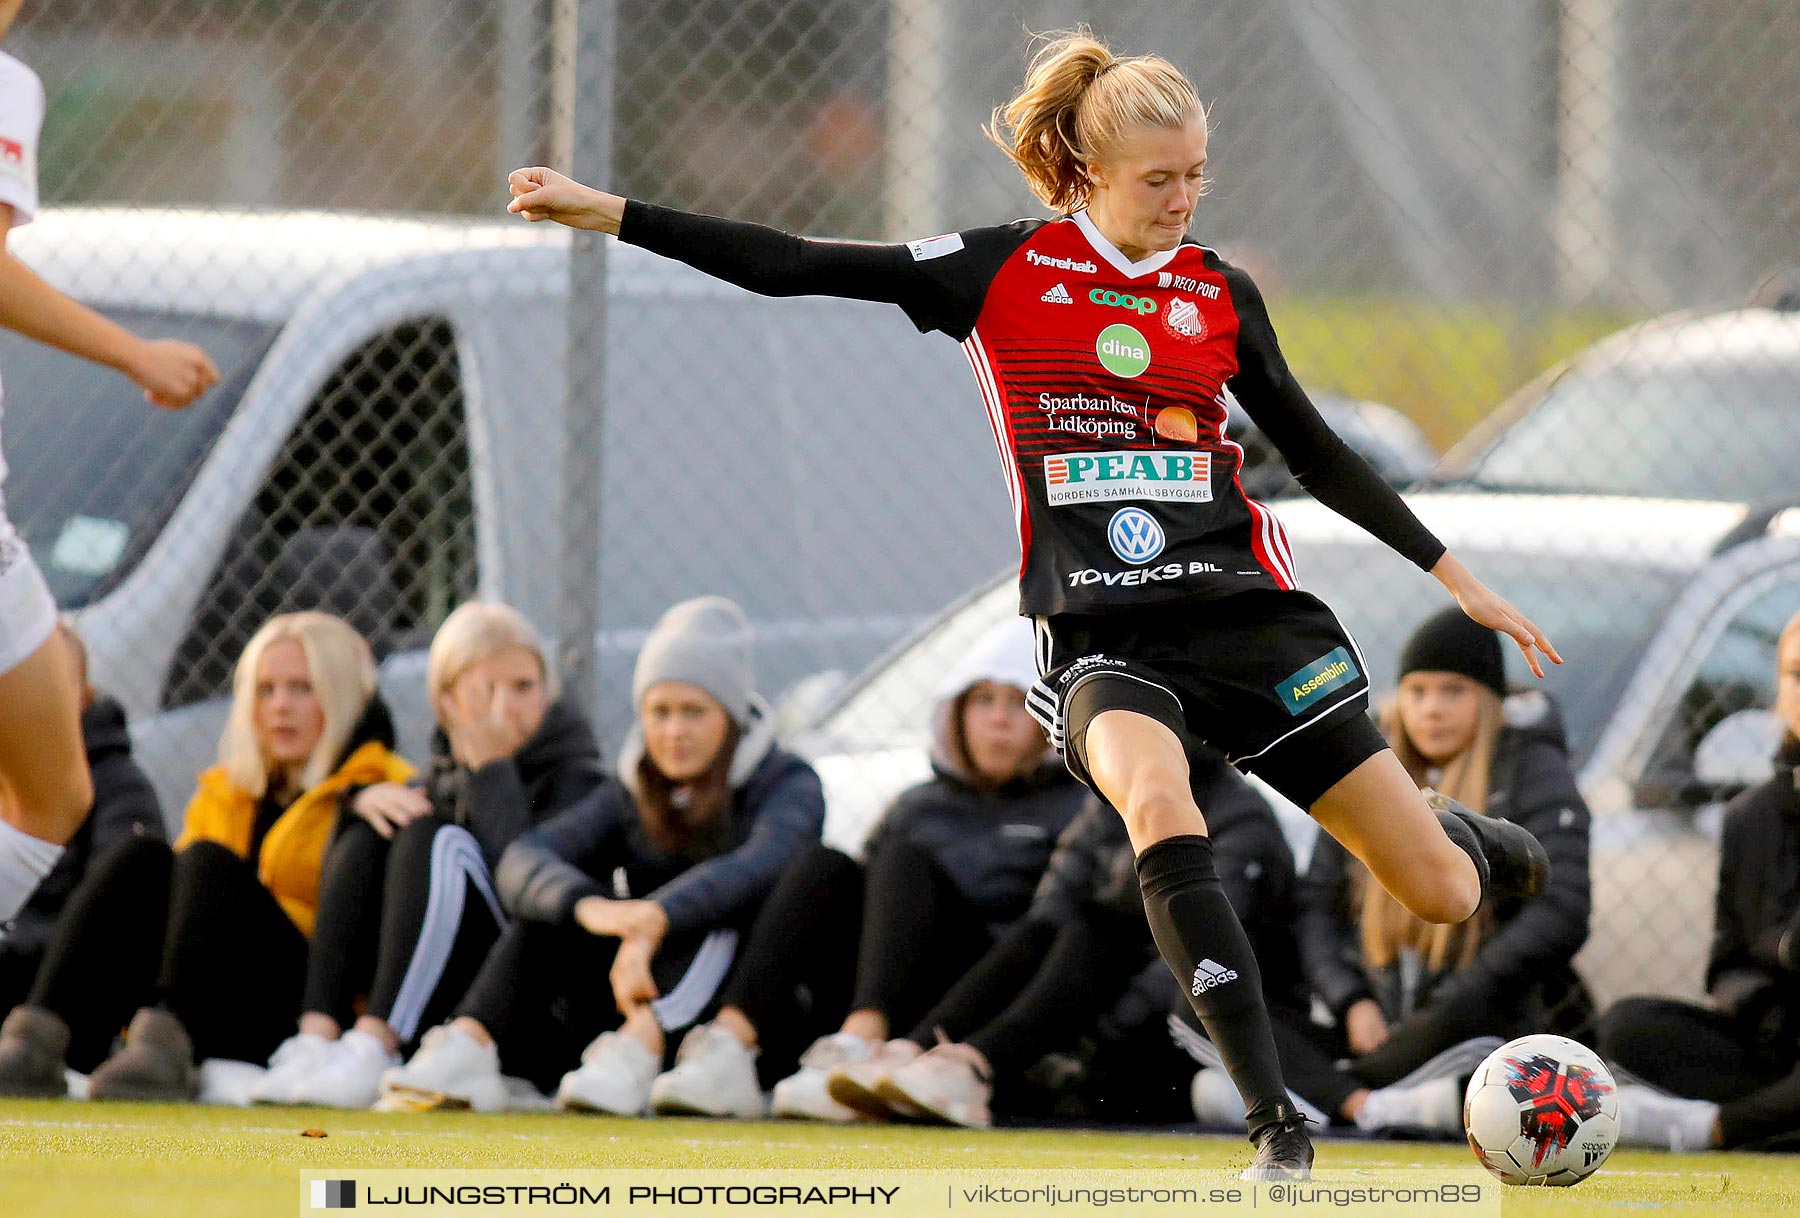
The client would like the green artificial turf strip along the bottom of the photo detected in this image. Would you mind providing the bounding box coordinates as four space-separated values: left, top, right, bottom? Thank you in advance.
0 1101 1800 1218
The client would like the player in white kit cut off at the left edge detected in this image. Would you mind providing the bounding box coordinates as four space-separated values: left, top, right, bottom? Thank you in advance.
0 0 220 925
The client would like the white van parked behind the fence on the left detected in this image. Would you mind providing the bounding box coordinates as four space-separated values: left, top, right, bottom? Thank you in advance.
0 209 1012 817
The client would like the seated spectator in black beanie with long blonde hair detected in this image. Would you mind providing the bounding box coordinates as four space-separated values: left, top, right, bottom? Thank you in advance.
1193 606 1589 1135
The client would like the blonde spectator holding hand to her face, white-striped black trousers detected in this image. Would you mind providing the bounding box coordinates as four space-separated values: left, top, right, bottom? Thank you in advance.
250 603 605 1108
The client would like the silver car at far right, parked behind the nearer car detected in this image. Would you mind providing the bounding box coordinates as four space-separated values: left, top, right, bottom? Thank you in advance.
1429 304 1800 502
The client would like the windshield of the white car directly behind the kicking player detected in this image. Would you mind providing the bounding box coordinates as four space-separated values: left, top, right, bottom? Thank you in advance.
817 540 1687 765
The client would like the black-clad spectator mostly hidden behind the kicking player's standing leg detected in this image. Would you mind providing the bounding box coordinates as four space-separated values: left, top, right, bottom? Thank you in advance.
877 747 1303 1128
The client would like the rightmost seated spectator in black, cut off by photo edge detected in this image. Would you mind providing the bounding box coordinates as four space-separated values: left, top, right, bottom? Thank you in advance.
1600 615 1800 1150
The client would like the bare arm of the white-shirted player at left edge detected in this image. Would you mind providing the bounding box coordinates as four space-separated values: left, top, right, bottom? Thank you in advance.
0 203 220 410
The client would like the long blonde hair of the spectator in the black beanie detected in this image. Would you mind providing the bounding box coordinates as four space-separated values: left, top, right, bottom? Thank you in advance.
1352 685 1505 972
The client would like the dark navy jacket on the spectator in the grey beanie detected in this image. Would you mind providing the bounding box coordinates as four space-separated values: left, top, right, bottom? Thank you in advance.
495 700 824 936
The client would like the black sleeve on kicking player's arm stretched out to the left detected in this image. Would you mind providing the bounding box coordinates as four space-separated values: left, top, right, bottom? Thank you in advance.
619 200 1042 342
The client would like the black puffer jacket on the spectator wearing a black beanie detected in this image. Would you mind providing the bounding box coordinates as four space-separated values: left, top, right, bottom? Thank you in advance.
1300 691 1589 1024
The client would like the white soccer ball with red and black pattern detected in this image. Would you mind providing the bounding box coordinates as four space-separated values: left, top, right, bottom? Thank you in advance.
1463 1034 1618 1187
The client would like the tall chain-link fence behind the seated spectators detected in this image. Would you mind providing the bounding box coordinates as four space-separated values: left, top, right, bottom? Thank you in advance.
0 0 1800 1036
